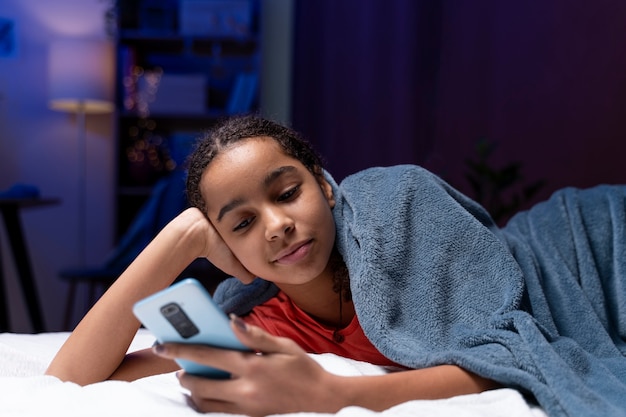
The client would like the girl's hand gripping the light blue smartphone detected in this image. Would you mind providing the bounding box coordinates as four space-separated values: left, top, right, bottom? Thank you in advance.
155 318 342 416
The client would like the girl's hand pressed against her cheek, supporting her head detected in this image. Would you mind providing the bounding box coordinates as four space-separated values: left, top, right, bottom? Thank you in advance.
176 207 255 283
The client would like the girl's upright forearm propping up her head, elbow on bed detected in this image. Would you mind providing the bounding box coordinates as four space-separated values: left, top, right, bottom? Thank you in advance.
46 213 207 384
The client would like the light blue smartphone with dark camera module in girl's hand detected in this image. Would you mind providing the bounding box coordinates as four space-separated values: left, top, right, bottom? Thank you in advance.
133 278 250 379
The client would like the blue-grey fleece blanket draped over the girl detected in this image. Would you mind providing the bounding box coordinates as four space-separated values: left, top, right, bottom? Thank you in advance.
215 166 626 417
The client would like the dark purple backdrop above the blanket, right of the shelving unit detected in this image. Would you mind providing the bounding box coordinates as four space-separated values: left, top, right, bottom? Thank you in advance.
293 0 626 221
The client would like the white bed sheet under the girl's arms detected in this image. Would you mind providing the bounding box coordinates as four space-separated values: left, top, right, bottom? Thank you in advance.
0 330 547 417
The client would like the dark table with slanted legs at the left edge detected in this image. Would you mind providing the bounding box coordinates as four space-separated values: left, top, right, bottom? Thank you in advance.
0 198 59 333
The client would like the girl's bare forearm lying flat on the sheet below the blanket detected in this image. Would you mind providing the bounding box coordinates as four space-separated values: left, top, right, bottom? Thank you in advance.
330 365 499 411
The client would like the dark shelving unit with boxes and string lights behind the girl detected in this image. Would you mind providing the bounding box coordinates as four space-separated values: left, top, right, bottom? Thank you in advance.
115 0 262 236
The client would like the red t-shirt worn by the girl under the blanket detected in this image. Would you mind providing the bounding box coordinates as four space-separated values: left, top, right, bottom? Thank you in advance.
243 291 397 366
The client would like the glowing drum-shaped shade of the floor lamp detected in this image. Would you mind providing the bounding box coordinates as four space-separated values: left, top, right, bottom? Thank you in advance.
48 39 114 113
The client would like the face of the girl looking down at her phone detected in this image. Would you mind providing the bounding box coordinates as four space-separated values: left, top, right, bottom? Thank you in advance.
200 137 335 289
